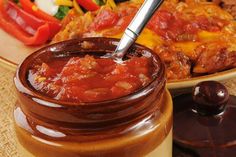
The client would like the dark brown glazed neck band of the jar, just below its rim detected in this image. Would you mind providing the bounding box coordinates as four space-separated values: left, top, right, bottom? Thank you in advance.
15 72 165 130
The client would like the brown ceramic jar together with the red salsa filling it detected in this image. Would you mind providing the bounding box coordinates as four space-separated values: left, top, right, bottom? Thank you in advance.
13 38 173 157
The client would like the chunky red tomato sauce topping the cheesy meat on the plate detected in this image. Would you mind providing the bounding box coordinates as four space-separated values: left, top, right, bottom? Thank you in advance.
90 7 228 41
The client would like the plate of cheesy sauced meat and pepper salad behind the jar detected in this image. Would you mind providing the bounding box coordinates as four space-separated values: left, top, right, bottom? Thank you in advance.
0 0 236 92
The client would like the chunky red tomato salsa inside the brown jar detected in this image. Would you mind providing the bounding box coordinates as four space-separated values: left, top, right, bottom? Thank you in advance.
28 55 153 102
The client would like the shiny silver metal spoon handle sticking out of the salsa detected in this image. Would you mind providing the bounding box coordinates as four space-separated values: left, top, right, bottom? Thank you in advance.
112 0 164 62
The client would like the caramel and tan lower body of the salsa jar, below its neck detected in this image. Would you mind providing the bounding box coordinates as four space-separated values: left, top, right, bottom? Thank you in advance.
14 90 173 157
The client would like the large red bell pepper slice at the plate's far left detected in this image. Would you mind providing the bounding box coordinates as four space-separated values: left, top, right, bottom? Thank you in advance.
0 0 58 45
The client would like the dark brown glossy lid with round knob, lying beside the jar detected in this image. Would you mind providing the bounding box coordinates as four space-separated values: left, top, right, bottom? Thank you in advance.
173 81 236 157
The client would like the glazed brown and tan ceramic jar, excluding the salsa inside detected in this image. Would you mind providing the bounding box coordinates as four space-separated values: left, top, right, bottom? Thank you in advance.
14 38 172 157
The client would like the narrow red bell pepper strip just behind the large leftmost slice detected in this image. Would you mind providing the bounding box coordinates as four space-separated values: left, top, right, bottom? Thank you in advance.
20 0 60 24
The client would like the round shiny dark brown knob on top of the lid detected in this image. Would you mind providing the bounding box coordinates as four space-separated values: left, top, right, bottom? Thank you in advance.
192 81 229 116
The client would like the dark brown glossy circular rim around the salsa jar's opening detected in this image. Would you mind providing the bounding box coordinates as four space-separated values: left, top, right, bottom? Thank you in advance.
14 37 165 107
